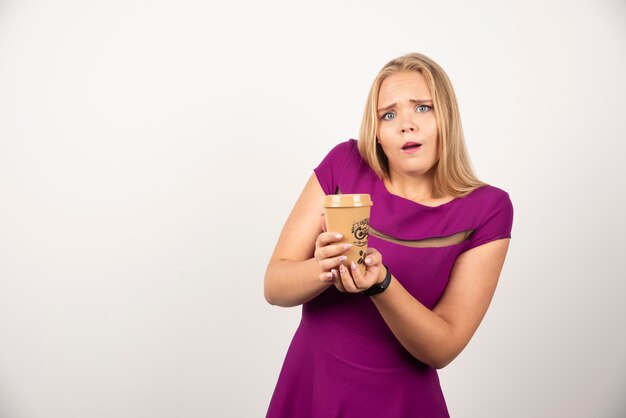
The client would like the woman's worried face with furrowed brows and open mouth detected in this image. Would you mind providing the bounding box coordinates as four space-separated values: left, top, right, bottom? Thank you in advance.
376 71 439 175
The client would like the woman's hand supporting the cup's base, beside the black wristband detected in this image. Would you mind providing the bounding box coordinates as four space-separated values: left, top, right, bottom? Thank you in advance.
333 248 387 293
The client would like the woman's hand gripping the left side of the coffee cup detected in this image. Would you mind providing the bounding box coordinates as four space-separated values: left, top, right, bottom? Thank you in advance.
314 232 352 292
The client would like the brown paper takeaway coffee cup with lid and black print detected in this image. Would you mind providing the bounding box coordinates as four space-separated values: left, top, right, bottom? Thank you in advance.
324 194 373 274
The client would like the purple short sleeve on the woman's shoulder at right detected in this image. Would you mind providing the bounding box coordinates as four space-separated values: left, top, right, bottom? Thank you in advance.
465 189 513 250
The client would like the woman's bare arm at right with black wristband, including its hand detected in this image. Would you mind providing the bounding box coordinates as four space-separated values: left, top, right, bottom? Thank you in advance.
341 239 509 369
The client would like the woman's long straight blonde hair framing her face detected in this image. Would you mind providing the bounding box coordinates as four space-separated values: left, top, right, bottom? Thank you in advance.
358 53 485 197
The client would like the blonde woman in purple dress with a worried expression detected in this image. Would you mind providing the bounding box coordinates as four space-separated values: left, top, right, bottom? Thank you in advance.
265 53 513 418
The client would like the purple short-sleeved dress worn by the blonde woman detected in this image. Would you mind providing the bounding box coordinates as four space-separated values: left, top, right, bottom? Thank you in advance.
267 139 513 418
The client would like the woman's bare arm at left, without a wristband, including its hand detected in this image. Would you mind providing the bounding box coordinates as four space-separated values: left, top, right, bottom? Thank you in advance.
264 174 346 306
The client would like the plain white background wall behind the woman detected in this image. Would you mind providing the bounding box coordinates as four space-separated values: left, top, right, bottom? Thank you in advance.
0 0 626 418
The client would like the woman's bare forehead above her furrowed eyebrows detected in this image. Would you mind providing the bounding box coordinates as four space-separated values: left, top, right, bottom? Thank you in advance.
378 71 431 105
